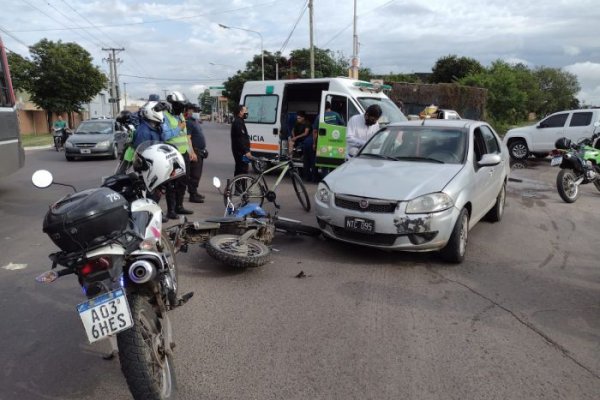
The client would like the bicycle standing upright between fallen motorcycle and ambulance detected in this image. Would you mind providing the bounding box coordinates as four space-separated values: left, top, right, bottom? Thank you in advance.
223 158 310 212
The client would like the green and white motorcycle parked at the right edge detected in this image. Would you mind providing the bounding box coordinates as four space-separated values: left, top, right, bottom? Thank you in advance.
550 122 600 203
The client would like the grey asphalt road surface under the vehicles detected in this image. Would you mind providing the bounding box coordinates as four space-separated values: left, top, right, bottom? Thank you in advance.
0 123 600 400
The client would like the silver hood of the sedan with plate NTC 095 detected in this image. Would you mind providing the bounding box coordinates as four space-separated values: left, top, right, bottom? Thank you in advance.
324 158 463 200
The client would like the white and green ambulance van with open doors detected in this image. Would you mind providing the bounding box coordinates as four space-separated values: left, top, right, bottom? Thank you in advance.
240 77 406 168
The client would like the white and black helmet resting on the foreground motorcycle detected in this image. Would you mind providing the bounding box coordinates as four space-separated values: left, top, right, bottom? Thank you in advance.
133 140 185 192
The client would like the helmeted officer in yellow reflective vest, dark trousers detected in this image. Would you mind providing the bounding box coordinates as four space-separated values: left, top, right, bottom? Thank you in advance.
163 91 198 219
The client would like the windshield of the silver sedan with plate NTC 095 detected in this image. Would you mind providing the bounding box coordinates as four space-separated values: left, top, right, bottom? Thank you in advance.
358 125 467 164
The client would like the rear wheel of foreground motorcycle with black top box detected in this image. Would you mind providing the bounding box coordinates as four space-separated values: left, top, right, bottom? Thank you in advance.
117 294 176 400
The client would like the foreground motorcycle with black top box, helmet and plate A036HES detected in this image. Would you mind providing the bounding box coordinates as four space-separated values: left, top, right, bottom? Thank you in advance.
32 143 193 400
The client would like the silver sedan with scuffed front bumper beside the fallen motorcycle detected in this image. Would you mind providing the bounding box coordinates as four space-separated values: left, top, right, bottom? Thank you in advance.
315 120 510 263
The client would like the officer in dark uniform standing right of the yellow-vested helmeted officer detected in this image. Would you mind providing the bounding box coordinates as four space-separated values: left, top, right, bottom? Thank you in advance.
185 103 208 203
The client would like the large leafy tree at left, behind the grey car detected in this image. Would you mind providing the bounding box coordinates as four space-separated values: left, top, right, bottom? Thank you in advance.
9 39 108 127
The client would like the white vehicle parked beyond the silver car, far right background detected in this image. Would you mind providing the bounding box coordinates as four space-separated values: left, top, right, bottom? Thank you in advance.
504 109 600 160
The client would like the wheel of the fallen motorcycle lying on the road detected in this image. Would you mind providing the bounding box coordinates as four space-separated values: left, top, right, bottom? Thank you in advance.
206 235 271 268
